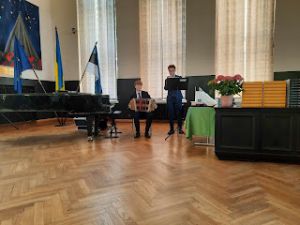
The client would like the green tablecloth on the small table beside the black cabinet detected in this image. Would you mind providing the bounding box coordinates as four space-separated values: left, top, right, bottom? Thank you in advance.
185 107 216 139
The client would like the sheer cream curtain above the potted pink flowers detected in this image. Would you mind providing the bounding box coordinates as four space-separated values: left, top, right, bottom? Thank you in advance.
216 0 276 81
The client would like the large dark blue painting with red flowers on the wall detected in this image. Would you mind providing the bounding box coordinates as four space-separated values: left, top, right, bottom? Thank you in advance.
0 0 42 76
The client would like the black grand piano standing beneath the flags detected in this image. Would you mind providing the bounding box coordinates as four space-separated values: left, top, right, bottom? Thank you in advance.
0 92 111 141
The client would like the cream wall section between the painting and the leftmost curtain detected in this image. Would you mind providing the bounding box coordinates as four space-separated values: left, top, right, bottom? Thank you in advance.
1 0 79 81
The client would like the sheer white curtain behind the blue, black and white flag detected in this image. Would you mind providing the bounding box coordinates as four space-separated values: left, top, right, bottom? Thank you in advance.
77 0 117 98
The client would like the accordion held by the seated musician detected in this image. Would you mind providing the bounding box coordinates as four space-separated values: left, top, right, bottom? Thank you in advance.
128 98 157 112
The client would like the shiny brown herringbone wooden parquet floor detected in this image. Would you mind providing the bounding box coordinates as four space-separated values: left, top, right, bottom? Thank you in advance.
0 121 300 225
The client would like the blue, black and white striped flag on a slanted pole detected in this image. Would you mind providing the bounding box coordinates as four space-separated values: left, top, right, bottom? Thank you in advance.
81 46 102 94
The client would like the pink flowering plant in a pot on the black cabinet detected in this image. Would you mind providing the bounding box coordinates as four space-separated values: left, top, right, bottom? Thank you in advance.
208 74 244 108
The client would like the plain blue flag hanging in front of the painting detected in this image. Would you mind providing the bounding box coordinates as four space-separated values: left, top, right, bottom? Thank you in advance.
14 37 32 94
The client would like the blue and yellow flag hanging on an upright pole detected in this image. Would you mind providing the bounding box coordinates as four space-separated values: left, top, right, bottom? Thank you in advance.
54 27 65 91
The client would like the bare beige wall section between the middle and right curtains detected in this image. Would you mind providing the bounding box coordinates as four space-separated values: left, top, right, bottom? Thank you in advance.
186 0 215 76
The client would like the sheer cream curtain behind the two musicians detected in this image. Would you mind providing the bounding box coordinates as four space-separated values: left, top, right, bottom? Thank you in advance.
140 0 186 98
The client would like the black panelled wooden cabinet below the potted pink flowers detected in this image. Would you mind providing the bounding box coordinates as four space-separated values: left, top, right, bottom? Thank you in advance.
216 109 300 162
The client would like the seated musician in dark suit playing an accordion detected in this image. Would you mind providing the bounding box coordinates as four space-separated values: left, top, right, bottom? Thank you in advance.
129 80 157 138
